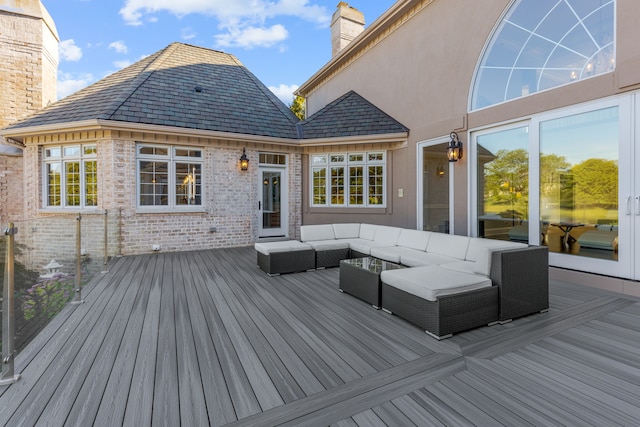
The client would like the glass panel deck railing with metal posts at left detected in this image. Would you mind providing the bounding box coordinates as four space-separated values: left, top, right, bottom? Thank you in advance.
0 210 122 381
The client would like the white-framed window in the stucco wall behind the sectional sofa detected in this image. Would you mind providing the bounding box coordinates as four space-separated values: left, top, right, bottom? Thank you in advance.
311 152 386 207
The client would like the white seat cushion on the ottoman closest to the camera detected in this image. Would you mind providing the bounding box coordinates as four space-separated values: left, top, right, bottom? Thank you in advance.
380 266 492 301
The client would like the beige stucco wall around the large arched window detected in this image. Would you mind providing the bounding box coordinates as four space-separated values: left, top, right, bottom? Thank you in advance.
303 0 640 234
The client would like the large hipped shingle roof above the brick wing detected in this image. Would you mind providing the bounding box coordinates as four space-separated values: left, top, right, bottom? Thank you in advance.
7 43 299 139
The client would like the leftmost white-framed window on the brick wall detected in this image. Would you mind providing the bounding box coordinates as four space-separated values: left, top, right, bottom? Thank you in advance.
44 144 98 208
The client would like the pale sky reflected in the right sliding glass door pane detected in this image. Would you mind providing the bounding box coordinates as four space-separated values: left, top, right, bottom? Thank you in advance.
540 107 618 165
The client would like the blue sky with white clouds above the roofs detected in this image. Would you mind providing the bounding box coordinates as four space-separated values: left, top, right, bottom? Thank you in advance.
42 0 395 105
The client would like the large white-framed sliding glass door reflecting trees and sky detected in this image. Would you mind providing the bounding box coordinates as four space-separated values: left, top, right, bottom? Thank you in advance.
470 95 640 279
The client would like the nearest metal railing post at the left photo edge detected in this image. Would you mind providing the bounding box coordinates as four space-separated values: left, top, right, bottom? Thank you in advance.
0 222 20 385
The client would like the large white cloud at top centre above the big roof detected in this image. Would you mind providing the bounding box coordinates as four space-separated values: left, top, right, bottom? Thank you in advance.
120 0 331 49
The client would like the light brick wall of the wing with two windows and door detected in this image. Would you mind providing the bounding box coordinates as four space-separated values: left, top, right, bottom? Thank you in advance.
16 133 302 270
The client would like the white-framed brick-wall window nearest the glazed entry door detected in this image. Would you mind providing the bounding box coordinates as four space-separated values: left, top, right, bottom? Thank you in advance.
137 144 203 209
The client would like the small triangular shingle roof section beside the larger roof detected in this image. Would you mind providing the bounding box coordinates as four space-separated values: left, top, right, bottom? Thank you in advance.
298 91 408 139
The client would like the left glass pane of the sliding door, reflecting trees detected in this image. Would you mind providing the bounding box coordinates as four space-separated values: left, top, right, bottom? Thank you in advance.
476 126 529 242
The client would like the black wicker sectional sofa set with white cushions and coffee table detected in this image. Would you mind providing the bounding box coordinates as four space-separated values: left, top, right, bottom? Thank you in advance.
255 223 549 339
